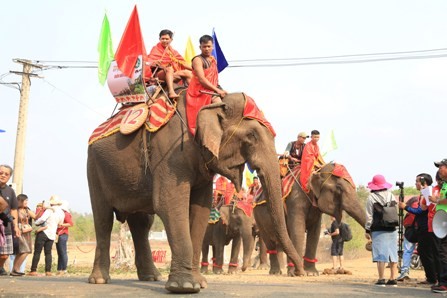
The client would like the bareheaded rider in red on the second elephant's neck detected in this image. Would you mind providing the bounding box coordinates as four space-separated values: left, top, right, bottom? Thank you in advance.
300 130 325 193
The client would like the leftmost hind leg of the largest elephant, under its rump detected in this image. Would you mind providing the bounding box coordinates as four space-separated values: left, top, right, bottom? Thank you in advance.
88 196 113 284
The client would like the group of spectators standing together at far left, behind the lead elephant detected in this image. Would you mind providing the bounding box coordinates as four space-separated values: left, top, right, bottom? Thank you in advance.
0 165 73 277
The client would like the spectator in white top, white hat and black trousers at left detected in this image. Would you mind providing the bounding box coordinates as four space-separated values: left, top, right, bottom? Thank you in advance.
28 195 65 276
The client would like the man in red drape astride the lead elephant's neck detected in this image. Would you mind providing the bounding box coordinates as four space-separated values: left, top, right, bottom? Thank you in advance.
186 35 227 135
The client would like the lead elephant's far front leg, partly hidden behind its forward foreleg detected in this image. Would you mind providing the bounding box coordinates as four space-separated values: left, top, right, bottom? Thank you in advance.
189 182 213 288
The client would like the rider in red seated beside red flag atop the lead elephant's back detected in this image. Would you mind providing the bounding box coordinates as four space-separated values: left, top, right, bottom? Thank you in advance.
147 29 192 98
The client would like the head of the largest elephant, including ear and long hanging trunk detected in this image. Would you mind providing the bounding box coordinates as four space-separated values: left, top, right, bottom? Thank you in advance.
196 93 302 268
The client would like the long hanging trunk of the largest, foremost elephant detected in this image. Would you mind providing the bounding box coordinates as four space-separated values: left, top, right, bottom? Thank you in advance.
258 164 303 274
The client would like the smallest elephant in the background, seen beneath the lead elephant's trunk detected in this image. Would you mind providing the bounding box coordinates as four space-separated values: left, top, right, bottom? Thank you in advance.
200 201 254 274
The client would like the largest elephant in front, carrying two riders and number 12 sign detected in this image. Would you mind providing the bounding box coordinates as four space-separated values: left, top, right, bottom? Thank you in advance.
87 90 304 293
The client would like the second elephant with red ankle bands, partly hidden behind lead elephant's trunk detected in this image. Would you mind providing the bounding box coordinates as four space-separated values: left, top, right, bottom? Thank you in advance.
253 163 366 276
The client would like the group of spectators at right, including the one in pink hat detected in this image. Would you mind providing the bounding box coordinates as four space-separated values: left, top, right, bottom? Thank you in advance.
365 159 447 293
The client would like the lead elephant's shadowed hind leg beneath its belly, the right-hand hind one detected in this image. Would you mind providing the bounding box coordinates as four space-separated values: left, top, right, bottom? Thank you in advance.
127 213 161 281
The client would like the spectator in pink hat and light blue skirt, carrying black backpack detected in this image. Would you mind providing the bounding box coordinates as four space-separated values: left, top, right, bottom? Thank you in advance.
365 175 397 287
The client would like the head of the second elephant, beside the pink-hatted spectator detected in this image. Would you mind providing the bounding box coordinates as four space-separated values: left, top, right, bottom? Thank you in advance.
310 163 366 227
